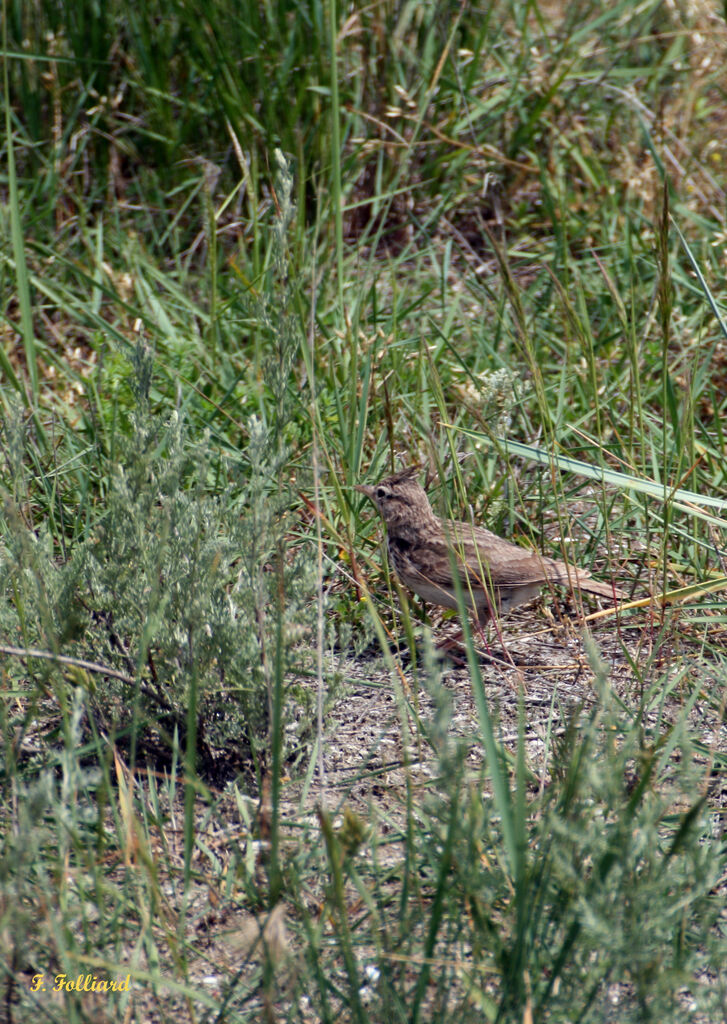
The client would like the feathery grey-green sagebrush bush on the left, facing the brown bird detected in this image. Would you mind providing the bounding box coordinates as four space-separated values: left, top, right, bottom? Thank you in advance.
2 344 319 774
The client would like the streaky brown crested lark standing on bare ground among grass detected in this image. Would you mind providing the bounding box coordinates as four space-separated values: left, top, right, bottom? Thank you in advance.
354 466 624 630
